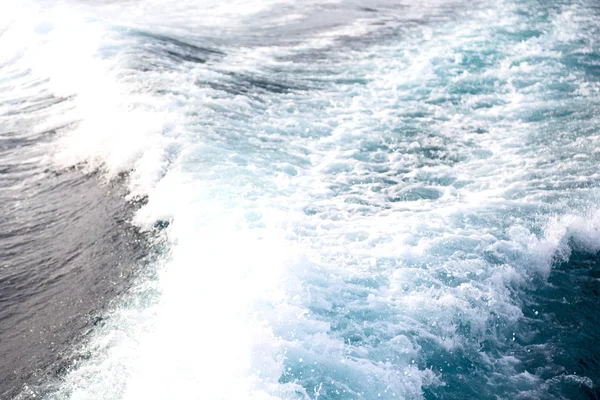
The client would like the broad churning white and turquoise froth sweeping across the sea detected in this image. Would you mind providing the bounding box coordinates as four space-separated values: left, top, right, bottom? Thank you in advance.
5 0 600 400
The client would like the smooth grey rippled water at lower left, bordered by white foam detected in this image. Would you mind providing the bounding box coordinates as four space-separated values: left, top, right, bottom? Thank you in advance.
0 167 149 399
